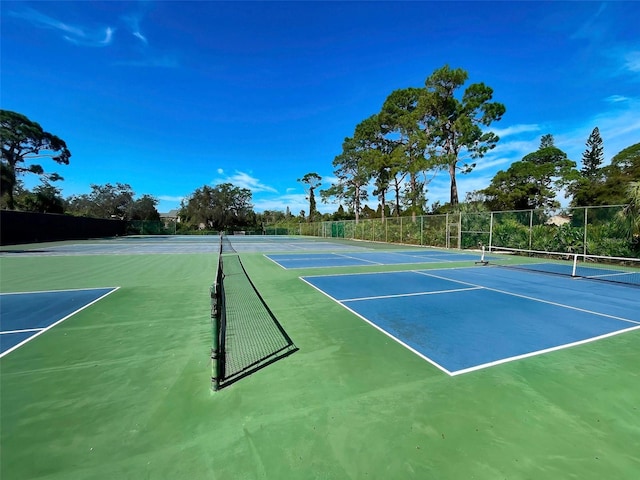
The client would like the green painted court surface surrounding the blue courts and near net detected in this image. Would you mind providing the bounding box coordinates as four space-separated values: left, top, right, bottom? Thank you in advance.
0 240 640 480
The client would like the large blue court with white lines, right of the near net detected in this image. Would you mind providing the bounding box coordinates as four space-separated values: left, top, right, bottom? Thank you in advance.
301 266 640 375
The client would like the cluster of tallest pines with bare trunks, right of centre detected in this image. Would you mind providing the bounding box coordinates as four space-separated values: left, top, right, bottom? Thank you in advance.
301 65 506 224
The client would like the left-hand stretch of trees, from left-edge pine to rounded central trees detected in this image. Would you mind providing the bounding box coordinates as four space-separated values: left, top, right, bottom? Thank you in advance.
0 110 280 230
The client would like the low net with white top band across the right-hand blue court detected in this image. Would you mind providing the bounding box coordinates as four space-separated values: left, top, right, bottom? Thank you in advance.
482 247 640 286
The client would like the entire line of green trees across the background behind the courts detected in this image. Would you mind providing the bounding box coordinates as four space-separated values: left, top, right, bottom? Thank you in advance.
0 61 640 230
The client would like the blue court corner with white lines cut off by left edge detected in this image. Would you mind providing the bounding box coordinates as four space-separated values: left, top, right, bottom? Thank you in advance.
0 288 117 357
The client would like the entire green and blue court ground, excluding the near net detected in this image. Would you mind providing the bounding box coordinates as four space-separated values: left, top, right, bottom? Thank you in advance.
0 235 640 480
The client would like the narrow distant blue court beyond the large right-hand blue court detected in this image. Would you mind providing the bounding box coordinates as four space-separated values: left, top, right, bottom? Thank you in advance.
266 250 480 269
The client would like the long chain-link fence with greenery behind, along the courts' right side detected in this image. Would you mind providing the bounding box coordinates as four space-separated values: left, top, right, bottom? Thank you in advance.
296 205 640 257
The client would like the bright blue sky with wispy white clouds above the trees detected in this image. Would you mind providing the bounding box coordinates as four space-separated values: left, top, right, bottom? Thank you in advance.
0 0 640 214
